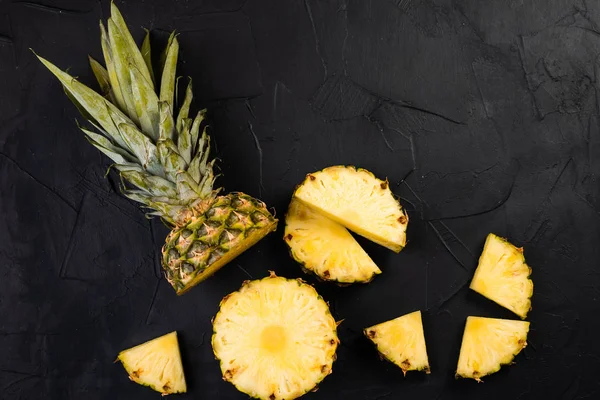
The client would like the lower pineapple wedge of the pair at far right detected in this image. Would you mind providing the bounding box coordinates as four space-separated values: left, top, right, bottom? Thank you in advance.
456 317 529 382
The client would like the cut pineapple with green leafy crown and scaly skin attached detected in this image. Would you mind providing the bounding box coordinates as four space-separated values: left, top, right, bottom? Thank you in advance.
33 3 277 294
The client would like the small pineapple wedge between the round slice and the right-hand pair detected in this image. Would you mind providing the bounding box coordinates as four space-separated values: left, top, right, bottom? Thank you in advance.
364 311 430 376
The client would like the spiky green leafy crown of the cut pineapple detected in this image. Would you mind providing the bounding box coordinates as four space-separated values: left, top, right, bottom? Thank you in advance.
36 3 220 225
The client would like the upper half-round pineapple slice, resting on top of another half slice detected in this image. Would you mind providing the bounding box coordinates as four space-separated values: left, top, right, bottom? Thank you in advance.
294 166 408 252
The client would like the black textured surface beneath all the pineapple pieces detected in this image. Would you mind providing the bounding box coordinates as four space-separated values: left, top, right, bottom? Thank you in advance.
0 0 600 400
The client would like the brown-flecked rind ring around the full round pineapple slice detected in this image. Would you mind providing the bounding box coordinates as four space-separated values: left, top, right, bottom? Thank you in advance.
211 271 340 400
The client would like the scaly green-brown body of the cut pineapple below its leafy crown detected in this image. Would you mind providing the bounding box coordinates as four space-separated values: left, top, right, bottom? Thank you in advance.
162 192 277 295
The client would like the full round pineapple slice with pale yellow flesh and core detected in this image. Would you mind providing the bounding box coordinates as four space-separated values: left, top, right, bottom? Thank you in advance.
212 273 339 400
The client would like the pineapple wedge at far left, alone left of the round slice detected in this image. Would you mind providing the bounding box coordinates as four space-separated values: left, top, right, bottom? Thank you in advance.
118 332 187 396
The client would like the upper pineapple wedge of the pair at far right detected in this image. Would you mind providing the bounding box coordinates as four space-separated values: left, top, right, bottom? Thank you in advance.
470 233 533 319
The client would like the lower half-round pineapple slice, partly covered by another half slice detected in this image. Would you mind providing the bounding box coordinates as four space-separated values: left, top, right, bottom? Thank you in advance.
284 199 381 283
